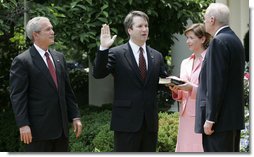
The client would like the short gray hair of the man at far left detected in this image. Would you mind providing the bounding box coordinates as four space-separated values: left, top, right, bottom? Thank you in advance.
26 16 49 41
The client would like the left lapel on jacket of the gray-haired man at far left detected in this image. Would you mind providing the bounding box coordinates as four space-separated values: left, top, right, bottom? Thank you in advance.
30 46 56 88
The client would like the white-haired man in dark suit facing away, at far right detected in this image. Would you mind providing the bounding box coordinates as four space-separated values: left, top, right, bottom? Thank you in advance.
195 3 245 152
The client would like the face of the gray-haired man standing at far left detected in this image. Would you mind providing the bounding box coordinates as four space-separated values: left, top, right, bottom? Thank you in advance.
34 20 54 47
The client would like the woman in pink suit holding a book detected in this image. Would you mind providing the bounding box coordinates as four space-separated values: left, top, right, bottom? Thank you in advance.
169 23 210 152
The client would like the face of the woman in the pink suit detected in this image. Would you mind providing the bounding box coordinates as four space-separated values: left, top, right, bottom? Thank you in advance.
186 31 205 52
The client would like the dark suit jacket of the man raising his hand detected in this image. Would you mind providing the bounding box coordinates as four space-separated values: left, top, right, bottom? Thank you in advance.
93 43 167 132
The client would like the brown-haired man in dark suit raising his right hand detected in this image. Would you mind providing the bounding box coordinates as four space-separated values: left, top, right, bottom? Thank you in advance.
93 11 167 152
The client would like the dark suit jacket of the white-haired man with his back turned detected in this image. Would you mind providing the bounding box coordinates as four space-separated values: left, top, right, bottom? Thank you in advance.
195 27 245 133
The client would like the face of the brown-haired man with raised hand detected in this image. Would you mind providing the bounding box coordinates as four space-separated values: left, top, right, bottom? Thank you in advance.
128 16 149 46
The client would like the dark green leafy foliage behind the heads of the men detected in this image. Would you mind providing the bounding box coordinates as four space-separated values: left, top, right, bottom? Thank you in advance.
0 0 212 109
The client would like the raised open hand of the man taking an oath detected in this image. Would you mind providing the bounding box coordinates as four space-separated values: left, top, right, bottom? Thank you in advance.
100 24 117 48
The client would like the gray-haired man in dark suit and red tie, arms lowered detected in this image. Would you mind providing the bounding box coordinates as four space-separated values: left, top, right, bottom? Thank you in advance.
10 17 82 152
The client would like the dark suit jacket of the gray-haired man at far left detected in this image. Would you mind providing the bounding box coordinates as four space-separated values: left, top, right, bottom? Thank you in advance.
10 46 80 140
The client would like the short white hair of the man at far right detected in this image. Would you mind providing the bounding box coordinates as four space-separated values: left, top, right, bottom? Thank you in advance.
206 3 230 25
